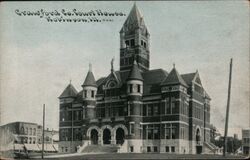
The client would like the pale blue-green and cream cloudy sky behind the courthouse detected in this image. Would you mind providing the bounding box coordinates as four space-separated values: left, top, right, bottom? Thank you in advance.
0 1 250 138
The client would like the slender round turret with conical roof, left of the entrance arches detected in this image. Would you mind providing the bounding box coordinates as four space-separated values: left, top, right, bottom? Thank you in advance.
82 64 97 118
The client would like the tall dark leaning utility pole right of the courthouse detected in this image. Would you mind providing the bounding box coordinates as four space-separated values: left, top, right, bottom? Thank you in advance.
223 58 233 157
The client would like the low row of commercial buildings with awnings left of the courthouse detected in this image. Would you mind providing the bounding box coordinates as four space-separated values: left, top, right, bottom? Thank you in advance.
0 122 58 152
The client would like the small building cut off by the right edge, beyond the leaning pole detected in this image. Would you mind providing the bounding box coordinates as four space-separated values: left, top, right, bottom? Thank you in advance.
242 129 250 155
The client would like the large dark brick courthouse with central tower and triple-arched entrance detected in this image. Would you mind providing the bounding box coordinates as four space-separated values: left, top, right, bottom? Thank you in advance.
59 5 214 154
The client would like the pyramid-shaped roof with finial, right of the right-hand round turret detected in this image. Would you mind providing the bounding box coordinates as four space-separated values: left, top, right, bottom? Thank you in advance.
161 67 188 87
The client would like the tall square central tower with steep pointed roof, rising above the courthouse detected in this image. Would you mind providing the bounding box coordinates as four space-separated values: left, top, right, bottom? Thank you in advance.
120 4 150 72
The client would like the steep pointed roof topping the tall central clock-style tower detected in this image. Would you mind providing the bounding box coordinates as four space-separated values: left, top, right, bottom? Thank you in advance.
120 4 147 32
